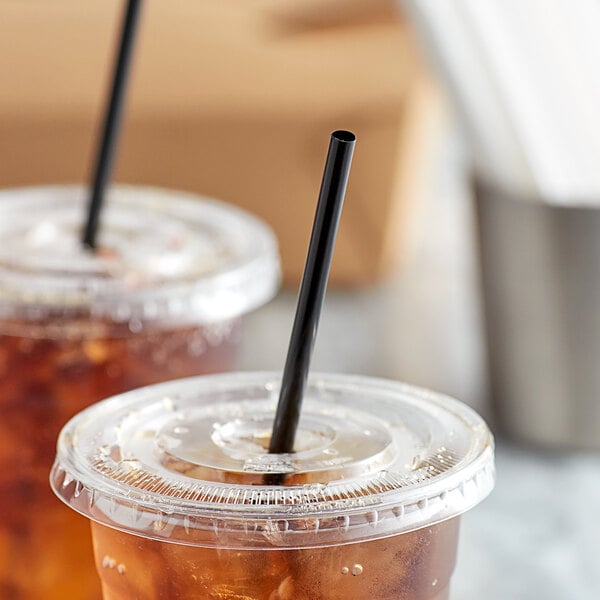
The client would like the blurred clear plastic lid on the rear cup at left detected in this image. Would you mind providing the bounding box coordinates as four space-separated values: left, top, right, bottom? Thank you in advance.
0 186 279 322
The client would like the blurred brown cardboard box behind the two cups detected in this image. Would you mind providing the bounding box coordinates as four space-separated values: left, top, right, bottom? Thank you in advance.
0 0 431 285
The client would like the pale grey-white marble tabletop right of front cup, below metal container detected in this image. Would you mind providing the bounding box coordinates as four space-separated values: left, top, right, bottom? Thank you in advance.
453 444 600 600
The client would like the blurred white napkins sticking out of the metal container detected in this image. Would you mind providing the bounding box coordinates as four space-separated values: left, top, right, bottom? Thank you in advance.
403 0 600 205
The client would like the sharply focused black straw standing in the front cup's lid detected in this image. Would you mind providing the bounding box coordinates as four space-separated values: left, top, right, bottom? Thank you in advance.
269 131 356 452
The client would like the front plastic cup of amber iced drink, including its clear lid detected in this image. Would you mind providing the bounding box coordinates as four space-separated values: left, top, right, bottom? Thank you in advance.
51 373 494 600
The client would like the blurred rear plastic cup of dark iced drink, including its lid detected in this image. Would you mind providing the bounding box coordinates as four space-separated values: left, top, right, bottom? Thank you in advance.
0 187 279 600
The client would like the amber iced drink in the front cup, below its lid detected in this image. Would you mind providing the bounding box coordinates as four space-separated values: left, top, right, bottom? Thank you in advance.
92 519 458 600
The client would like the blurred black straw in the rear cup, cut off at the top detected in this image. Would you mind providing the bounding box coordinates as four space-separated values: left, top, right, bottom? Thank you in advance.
82 0 140 249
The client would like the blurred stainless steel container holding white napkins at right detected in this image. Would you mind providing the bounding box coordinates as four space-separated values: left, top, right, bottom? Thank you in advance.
473 176 600 449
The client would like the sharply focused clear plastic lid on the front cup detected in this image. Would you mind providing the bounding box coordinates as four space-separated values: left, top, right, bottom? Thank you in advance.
51 373 494 548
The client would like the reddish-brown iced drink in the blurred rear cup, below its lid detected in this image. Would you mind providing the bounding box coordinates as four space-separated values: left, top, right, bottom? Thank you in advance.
0 321 239 600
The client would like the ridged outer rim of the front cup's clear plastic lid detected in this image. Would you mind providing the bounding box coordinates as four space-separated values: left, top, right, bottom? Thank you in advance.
50 373 495 548
